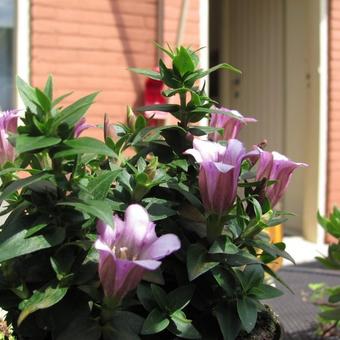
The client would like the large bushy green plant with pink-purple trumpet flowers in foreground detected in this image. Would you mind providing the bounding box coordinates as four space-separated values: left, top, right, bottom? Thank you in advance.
0 47 304 340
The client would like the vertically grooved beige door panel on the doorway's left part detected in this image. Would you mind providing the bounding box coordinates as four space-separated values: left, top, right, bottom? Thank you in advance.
229 0 285 150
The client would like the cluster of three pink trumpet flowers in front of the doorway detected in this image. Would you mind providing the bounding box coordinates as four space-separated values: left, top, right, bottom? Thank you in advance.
185 109 307 215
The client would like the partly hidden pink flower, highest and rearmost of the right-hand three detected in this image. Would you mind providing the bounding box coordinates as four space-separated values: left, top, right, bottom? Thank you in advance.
209 108 257 142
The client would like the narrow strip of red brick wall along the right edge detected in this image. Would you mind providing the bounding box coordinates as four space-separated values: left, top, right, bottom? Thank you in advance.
327 0 340 212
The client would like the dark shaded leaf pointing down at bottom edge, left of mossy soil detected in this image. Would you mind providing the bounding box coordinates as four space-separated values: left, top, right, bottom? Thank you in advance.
214 303 241 340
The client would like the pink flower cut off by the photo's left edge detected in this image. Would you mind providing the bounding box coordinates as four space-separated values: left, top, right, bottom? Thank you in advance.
0 110 19 164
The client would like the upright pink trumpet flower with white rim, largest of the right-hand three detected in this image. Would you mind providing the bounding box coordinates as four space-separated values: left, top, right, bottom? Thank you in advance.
184 139 258 215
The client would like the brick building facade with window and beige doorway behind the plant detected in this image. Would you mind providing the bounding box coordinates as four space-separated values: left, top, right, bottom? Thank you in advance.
0 0 340 242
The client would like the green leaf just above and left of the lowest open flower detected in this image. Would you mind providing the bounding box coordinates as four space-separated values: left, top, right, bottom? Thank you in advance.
58 200 113 227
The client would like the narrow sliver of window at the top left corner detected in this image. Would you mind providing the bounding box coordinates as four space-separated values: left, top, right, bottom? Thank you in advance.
0 0 15 110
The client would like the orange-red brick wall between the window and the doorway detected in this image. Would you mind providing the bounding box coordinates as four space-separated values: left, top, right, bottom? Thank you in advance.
31 0 199 136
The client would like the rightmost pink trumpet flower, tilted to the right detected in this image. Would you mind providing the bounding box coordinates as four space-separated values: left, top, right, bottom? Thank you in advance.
256 149 308 207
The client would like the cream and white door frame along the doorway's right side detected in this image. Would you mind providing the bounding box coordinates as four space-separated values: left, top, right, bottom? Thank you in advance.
207 0 329 244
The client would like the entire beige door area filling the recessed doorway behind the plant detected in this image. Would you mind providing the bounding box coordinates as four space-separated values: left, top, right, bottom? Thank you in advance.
211 0 308 234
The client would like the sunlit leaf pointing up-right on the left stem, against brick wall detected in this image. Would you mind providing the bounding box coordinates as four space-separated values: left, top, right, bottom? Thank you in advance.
51 92 98 130
